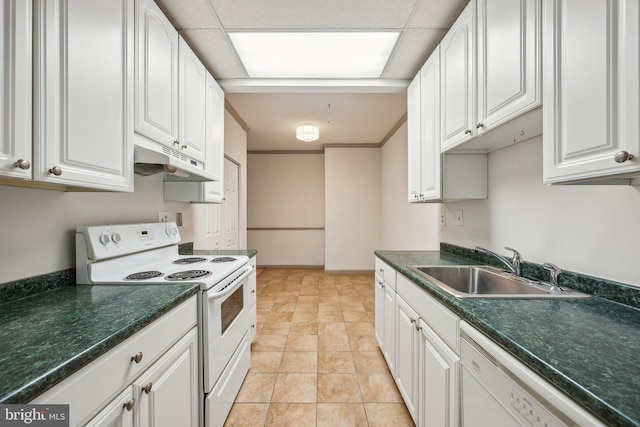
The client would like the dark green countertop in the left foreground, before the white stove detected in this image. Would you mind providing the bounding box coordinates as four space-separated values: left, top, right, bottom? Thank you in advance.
0 283 199 403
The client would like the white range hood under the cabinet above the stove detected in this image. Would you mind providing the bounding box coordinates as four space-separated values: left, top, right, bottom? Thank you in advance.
133 138 218 182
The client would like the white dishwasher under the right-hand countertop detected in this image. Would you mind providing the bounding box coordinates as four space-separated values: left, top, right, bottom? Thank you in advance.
460 321 604 427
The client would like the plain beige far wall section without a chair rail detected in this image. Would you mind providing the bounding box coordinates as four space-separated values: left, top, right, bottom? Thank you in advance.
324 148 382 271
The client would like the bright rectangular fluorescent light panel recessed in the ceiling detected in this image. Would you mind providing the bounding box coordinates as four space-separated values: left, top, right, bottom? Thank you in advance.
229 32 399 79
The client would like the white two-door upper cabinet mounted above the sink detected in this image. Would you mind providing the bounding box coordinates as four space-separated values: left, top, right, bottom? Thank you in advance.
440 0 542 153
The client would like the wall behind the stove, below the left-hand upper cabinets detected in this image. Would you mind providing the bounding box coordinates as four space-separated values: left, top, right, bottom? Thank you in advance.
0 174 192 283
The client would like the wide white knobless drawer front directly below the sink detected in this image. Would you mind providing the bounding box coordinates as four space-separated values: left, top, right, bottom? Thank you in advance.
397 274 460 352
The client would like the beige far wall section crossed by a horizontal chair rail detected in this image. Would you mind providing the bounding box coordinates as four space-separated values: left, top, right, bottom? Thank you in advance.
248 154 325 266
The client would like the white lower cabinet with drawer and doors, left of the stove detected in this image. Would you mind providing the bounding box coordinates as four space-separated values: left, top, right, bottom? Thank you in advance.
29 296 196 427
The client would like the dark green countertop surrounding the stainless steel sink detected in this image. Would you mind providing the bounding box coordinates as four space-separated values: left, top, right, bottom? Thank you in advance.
375 251 640 426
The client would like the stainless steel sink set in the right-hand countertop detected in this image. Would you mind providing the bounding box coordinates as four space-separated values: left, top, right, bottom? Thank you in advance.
409 265 589 298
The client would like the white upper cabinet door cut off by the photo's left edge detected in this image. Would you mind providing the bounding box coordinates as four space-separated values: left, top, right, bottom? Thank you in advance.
0 0 33 179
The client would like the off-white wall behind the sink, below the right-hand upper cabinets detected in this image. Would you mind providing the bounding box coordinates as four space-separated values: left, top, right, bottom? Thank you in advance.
441 137 640 286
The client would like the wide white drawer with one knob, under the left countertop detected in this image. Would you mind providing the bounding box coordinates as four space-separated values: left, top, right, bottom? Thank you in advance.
30 296 197 425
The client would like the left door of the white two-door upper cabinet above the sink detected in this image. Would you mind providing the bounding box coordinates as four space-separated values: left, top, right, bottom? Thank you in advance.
440 1 476 151
